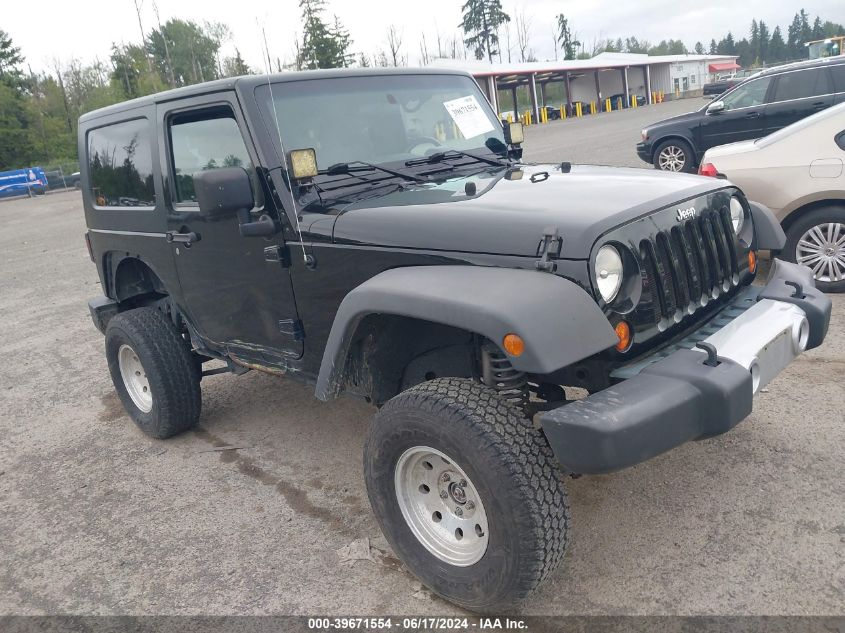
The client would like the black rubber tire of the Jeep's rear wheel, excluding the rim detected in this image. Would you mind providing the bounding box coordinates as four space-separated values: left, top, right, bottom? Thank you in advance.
106 308 202 439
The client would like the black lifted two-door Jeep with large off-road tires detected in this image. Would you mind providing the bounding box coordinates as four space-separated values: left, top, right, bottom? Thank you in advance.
79 69 830 611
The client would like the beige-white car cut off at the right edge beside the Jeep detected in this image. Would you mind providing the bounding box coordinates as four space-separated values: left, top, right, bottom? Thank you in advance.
698 103 845 292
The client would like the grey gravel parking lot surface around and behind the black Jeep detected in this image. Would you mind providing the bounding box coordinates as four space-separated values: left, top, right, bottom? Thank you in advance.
0 100 845 614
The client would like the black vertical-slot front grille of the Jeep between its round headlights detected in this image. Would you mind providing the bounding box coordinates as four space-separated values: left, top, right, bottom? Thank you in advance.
639 207 740 330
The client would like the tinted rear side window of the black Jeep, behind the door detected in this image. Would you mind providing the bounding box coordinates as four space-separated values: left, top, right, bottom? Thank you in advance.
88 119 155 208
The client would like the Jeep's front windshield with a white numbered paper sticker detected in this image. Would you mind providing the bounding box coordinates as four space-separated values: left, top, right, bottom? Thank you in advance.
256 74 506 170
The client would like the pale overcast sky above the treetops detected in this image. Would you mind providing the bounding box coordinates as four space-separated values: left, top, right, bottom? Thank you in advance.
6 0 845 71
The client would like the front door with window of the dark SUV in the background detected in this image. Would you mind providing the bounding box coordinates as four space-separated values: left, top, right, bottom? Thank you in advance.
699 77 772 152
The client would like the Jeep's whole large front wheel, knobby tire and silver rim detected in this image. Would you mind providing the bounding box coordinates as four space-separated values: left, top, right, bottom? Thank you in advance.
364 378 569 612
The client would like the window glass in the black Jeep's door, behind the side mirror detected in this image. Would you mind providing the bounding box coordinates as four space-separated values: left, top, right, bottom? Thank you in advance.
168 107 264 208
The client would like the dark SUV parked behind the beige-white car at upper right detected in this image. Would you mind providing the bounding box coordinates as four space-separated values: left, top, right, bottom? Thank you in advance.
637 57 845 172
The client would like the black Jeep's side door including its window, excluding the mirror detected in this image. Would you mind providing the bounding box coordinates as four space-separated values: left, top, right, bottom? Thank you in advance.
157 93 303 365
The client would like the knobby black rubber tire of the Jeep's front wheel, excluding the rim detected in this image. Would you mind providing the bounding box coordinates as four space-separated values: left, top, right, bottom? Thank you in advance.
364 378 569 612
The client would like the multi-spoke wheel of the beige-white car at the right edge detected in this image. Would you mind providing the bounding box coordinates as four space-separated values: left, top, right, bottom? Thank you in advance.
782 207 845 292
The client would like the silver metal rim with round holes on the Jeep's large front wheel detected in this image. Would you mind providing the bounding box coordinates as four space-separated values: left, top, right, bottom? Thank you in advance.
394 446 489 567
